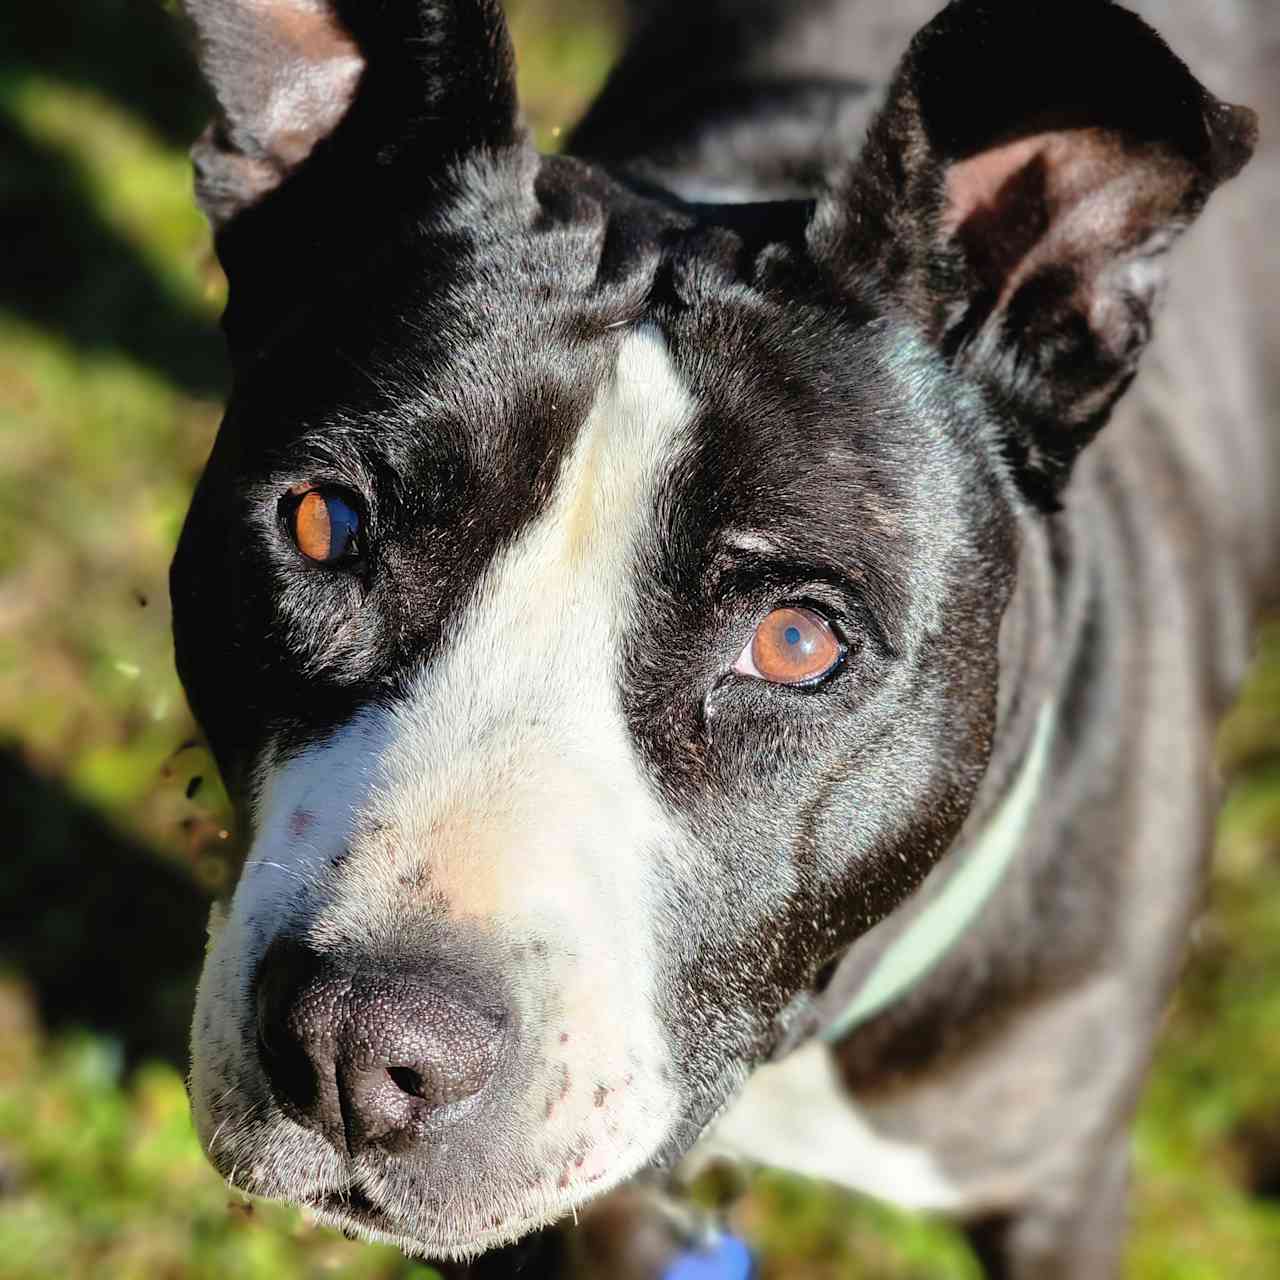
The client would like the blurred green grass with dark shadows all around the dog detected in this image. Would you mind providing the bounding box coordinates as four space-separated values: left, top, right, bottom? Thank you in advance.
0 0 1280 1280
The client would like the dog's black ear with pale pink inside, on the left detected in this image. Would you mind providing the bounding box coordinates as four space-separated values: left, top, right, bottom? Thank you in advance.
184 0 524 355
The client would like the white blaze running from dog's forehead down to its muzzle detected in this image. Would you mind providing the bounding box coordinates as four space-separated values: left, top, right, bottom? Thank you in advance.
196 329 692 1204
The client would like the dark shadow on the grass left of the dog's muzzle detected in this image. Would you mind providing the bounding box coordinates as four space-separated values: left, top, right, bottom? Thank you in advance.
0 749 209 1071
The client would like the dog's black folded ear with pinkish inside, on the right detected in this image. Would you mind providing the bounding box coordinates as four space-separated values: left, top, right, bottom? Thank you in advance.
809 0 1257 507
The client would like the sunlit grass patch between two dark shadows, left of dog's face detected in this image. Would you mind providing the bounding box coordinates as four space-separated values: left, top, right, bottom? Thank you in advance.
0 316 216 838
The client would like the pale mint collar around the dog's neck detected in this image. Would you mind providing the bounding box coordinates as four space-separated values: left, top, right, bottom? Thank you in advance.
820 700 1057 1044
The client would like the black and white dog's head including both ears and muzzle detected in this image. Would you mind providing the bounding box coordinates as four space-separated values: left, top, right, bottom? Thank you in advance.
173 0 1252 1256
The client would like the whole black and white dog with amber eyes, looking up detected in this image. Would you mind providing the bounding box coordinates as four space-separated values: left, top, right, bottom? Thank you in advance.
173 0 1280 1280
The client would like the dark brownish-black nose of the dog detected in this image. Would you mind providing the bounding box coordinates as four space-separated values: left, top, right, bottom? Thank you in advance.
257 938 506 1155
